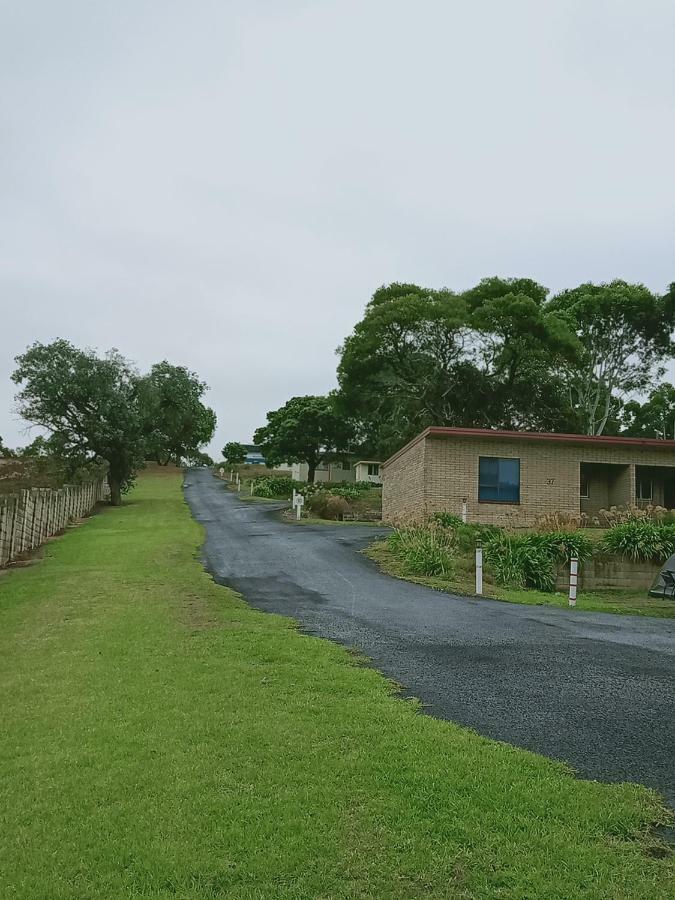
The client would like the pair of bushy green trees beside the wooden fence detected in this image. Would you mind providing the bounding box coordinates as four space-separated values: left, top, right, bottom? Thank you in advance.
12 339 215 505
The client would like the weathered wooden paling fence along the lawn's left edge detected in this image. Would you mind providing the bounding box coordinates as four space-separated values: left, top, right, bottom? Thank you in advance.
0 478 108 568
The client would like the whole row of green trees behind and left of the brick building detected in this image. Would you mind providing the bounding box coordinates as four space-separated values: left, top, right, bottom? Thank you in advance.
255 277 675 472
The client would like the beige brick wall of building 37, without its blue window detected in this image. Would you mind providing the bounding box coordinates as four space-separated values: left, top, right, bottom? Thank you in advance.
383 434 675 527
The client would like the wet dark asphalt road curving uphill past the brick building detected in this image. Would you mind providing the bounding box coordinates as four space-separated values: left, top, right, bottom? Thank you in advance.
185 469 675 805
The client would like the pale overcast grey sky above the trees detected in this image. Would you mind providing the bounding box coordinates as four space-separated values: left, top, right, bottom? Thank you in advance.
0 0 675 448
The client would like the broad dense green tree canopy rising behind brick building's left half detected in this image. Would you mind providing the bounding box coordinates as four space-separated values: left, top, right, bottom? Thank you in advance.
338 278 578 455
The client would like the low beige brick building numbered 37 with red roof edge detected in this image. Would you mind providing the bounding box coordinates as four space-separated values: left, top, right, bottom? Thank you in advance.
381 427 675 527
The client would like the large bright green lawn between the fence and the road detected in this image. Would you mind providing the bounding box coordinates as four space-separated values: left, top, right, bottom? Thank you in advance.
0 474 673 900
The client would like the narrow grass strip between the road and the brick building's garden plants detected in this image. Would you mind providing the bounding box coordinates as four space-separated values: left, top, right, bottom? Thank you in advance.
363 541 675 619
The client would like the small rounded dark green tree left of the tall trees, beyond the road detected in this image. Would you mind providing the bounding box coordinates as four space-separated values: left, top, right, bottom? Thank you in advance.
253 396 351 482
